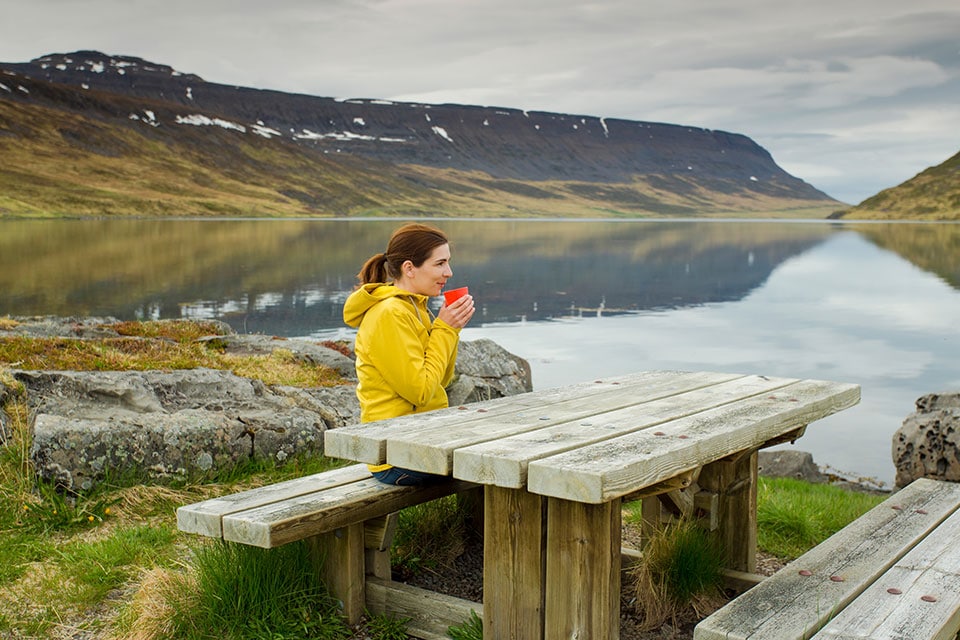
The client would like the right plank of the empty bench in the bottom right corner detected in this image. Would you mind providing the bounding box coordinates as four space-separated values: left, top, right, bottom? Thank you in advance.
814 504 960 640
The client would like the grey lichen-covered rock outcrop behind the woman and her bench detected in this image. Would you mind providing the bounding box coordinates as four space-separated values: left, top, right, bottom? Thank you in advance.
0 320 532 491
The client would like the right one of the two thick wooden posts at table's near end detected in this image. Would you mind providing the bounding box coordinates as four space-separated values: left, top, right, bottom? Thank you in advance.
544 498 620 638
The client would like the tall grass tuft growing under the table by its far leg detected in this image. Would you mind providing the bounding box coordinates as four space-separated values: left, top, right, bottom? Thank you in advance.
631 520 724 630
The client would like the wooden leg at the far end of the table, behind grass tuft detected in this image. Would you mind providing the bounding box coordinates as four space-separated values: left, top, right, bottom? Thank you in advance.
699 451 757 573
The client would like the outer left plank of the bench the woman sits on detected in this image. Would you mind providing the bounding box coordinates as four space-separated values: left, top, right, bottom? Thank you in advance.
177 464 370 538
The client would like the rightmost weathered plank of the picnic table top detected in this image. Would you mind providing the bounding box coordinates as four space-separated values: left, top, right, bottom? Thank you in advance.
527 380 860 503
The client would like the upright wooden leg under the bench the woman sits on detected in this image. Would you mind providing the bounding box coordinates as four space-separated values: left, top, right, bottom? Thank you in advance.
308 522 365 624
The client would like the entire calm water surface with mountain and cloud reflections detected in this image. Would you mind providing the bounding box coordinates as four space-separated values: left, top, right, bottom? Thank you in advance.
0 220 960 484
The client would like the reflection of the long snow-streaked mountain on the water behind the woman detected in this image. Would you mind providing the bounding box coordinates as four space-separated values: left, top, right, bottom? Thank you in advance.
0 220 830 335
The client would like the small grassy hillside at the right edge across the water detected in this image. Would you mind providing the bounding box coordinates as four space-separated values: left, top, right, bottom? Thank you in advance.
832 153 960 221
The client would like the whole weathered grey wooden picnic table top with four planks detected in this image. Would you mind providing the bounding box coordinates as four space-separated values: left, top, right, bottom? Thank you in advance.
325 371 860 504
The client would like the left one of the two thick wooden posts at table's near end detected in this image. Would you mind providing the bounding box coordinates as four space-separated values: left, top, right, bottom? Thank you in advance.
483 485 544 640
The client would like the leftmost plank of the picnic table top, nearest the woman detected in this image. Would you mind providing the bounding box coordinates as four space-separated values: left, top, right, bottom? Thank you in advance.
323 371 736 464
